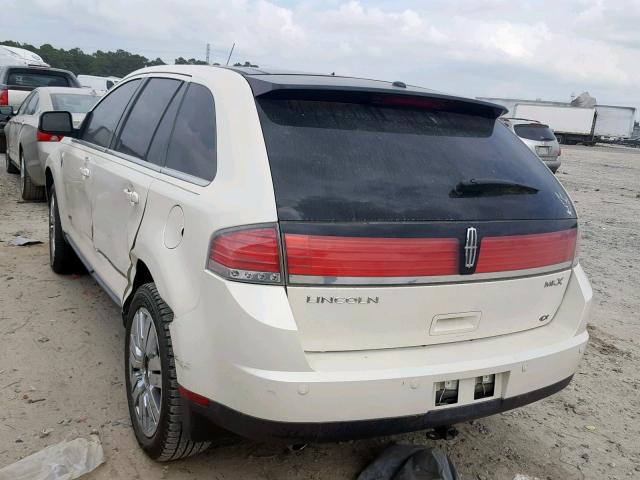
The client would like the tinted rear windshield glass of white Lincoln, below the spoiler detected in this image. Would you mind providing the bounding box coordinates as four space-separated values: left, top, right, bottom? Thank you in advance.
256 92 575 222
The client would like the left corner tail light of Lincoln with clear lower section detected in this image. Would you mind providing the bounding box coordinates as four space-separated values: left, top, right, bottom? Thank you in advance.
207 226 282 283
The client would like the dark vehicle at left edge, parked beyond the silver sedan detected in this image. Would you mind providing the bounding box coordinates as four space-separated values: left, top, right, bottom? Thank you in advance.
0 65 80 153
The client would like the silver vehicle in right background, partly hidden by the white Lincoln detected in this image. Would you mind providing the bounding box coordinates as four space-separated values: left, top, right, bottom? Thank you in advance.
500 117 561 173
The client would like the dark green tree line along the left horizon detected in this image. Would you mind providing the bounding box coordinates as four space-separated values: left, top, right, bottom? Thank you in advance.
0 40 257 77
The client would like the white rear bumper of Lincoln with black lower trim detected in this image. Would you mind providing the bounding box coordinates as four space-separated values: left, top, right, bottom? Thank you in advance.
171 266 592 440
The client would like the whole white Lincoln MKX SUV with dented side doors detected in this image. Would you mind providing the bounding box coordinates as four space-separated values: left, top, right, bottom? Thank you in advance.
40 65 592 460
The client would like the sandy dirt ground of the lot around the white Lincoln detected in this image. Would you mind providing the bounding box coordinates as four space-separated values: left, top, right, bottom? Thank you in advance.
0 147 640 480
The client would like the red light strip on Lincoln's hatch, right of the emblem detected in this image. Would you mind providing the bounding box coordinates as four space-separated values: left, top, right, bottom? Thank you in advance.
476 228 577 273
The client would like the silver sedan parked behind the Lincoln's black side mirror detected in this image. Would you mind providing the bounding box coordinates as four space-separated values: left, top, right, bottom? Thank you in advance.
4 87 103 200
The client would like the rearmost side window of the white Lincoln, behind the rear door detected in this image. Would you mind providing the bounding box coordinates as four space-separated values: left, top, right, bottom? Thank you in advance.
166 84 216 181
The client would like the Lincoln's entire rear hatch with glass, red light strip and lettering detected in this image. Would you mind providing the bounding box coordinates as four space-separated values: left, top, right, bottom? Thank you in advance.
256 90 577 351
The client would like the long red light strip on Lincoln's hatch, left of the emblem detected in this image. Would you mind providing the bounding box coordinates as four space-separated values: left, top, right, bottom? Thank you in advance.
285 234 459 282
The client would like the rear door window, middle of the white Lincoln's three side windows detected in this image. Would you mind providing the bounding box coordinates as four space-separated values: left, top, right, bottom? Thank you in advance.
114 78 182 159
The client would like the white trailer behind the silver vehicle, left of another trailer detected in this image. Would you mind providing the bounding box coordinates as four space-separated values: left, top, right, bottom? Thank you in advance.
513 103 597 144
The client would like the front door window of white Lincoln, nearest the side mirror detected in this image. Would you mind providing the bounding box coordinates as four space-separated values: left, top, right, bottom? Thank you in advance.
82 79 140 147
